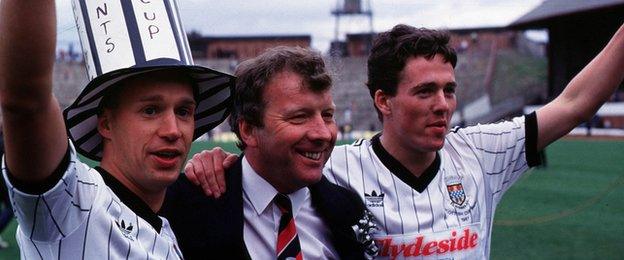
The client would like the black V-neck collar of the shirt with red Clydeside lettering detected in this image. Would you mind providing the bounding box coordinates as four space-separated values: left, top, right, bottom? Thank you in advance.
371 133 440 192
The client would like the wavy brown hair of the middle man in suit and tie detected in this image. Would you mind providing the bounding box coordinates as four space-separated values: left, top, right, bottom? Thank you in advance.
228 46 332 150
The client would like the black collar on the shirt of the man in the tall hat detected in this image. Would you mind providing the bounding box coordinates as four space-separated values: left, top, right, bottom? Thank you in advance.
95 166 162 233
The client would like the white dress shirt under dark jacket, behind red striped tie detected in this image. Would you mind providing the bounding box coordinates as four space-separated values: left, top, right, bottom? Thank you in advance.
242 157 338 259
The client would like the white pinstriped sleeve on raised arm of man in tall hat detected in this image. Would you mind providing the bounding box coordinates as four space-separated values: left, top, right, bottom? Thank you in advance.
2 142 104 242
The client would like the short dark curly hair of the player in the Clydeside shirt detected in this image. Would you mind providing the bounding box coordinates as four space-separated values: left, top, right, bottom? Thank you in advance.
366 24 457 120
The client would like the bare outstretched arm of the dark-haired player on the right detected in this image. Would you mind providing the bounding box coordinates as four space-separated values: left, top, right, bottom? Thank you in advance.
537 25 624 150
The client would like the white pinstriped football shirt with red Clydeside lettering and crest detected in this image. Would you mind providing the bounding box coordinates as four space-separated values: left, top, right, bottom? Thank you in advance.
324 114 537 259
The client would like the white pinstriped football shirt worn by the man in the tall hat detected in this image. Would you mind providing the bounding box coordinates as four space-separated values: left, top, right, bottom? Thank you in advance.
2 143 182 259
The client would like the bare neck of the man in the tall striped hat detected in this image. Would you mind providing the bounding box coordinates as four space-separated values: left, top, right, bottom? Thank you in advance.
100 157 166 212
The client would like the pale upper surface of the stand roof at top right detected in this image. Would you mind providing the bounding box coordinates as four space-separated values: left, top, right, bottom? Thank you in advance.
509 0 624 28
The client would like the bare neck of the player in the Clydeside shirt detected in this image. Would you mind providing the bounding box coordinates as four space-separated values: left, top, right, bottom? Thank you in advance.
379 133 436 177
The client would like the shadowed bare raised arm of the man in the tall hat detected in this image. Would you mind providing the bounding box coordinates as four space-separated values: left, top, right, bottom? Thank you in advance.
0 0 67 182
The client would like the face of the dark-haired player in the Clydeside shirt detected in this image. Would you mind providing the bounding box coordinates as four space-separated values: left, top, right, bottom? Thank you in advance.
375 54 457 155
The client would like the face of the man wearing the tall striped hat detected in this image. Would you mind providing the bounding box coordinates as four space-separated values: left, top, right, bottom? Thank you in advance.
98 72 195 196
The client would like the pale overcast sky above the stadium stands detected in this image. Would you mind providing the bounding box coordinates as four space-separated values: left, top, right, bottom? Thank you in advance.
57 0 542 52
